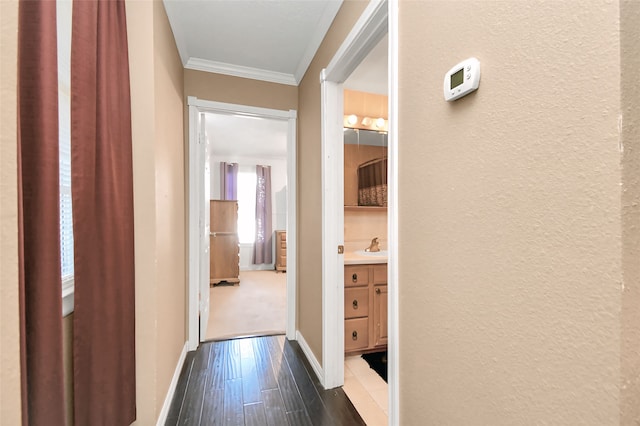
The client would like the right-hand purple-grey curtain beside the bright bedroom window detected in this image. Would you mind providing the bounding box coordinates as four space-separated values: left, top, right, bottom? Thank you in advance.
253 165 272 265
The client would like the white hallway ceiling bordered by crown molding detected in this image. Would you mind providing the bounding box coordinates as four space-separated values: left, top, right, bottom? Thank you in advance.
164 0 342 86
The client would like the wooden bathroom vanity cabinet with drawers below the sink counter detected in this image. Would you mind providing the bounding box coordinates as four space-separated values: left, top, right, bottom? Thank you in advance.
344 264 387 354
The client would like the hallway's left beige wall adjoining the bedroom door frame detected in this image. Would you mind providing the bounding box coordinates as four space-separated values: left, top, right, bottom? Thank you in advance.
153 1 187 415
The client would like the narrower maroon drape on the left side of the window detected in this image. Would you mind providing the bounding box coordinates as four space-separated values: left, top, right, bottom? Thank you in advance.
18 1 65 426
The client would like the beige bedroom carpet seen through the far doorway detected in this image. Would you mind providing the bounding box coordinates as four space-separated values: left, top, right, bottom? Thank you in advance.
207 271 287 340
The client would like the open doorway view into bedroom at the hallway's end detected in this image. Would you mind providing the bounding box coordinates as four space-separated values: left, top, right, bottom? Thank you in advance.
201 112 288 340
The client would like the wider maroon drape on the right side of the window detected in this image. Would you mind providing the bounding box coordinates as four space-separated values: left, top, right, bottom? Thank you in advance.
71 0 136 426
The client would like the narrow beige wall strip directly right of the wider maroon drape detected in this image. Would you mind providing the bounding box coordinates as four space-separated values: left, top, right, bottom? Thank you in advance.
127 1 158 425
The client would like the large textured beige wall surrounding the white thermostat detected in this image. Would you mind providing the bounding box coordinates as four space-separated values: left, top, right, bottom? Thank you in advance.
399 0 640 425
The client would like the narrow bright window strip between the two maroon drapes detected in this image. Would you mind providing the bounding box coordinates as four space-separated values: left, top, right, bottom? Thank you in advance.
56 0 74 316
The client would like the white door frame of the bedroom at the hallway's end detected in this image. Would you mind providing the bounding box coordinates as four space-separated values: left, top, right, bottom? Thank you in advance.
187 96 297 350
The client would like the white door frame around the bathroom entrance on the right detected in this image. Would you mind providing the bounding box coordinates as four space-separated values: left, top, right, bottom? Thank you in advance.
320 0 399 425
